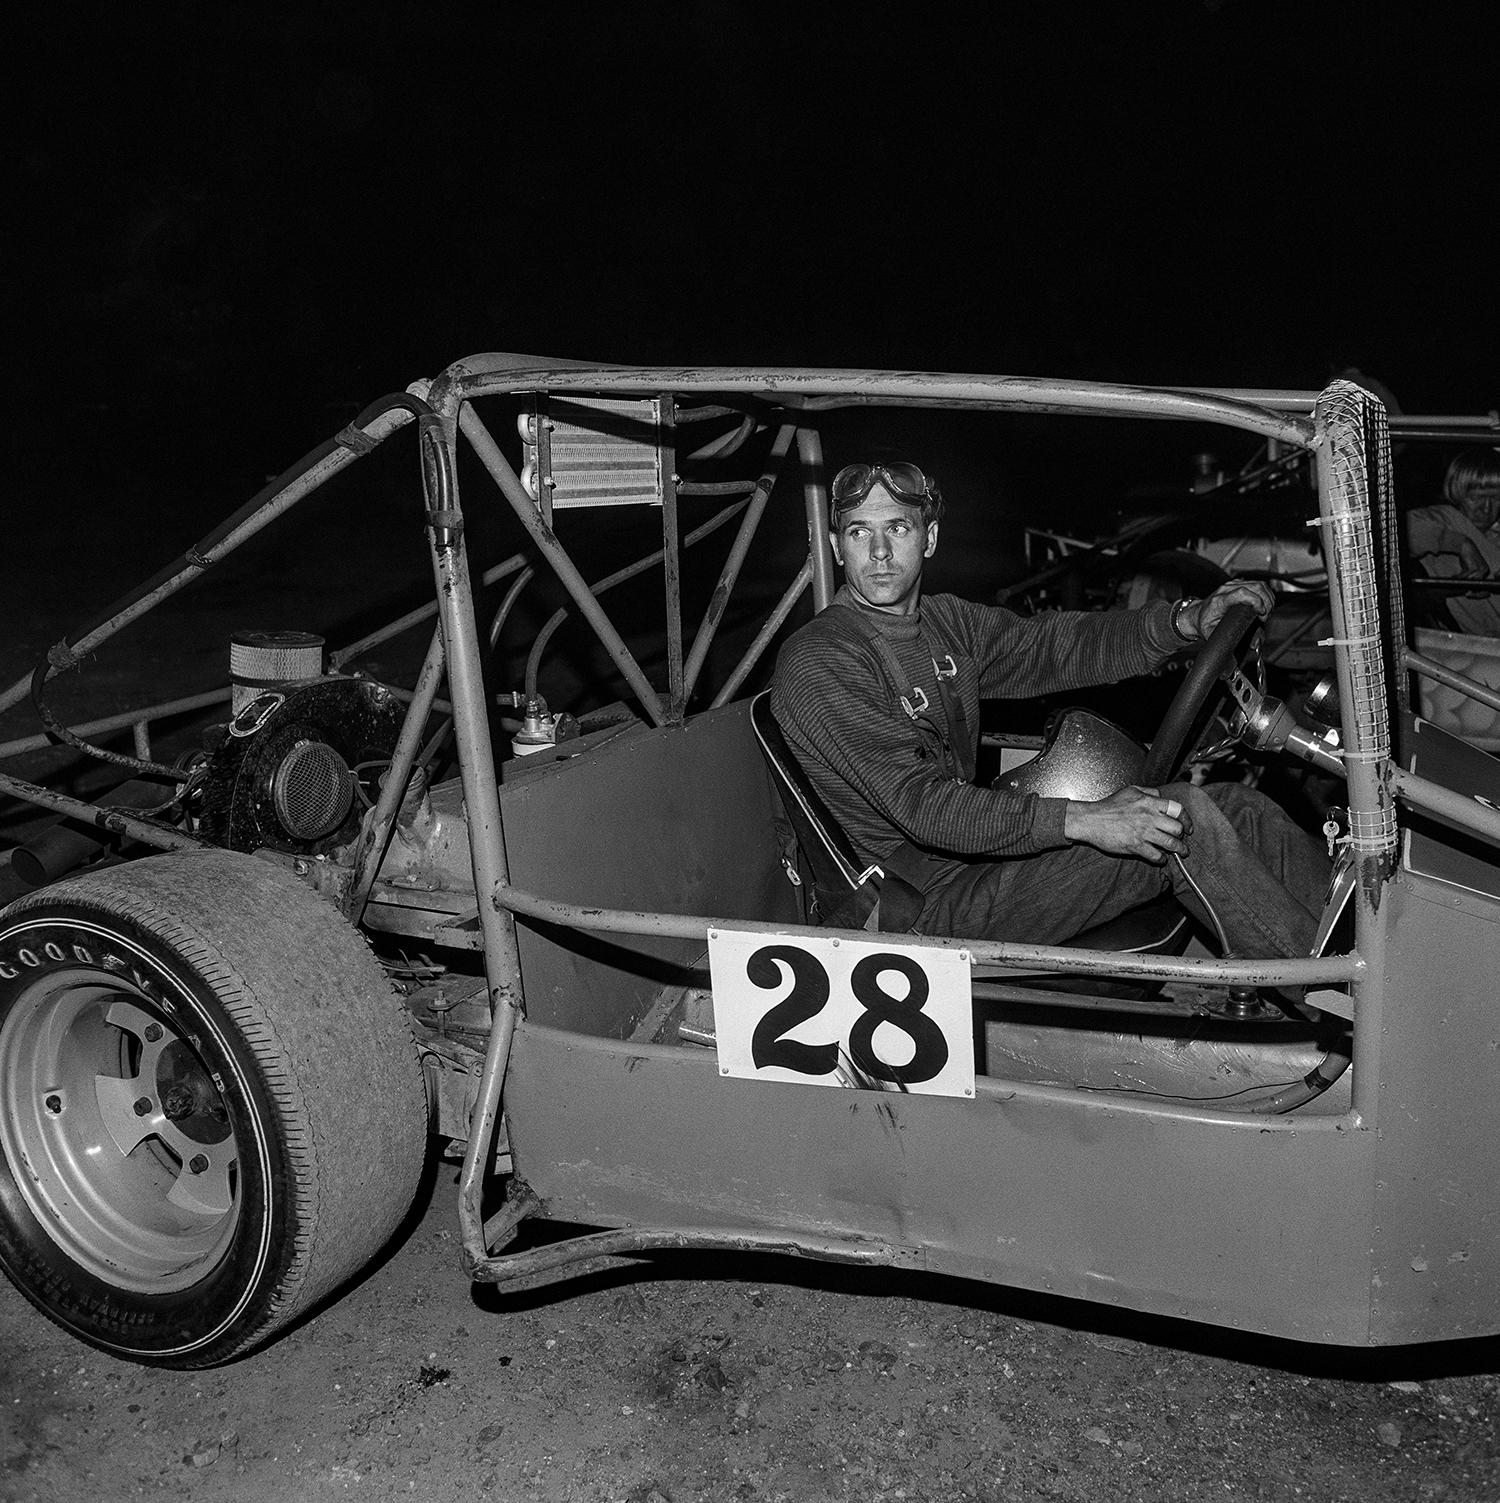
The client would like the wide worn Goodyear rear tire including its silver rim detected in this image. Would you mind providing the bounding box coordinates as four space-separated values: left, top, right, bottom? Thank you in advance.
0 851 427 1368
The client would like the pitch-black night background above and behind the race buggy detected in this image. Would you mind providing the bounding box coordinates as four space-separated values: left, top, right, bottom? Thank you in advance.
3 0 1500 763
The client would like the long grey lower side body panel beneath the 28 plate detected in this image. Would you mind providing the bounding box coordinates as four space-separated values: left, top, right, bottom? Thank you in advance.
505 1021 1375 1344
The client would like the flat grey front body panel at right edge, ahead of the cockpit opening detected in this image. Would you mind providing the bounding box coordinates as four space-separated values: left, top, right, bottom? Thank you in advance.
1371 872 1500 1342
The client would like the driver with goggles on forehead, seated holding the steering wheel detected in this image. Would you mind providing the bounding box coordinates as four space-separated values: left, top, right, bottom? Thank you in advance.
771 463 1329 957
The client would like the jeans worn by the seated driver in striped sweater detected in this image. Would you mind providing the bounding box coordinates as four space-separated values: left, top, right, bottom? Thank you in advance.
917 783 1330 959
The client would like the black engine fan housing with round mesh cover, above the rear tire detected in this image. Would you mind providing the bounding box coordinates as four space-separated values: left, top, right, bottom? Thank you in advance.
201 678 404 855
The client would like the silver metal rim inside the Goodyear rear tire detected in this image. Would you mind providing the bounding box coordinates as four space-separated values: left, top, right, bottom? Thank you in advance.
0 971 240 1294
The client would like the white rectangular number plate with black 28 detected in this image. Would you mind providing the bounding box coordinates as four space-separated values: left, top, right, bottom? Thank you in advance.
708 929 974 1096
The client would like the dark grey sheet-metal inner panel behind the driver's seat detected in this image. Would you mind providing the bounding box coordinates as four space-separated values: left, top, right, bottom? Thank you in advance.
501 703 801 1036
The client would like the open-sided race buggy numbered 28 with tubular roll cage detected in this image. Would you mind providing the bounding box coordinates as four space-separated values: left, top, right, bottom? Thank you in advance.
0 355 1500 1368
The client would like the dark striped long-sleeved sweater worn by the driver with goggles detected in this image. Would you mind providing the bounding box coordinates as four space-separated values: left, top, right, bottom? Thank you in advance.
771 589 1181 885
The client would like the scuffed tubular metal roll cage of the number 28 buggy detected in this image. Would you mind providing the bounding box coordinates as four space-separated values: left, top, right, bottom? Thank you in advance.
0 355 1500 1290
